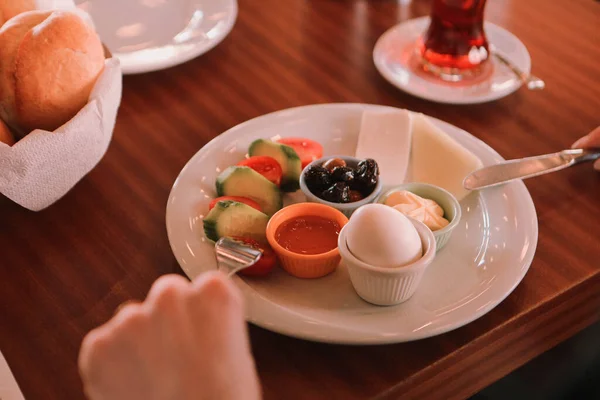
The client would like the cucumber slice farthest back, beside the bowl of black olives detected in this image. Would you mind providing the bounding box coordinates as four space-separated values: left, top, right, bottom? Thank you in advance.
248 139 302 192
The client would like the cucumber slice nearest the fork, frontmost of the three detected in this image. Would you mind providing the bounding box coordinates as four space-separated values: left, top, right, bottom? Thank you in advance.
203 200 269 243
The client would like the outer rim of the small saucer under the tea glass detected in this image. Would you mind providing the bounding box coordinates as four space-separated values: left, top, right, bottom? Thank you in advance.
372 16 531 105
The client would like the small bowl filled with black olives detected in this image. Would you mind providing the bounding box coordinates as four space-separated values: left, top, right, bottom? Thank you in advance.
300 156 382 217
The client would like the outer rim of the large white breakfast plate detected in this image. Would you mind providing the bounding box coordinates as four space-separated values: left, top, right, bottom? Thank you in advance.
165 103 539 345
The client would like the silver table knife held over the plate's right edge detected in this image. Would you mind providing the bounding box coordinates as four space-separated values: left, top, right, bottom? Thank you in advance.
463 148 600 190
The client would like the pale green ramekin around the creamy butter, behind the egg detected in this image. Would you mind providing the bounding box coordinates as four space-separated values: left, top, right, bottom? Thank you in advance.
376 182 462 251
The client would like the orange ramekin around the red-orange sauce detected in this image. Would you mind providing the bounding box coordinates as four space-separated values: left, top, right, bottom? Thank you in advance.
267 203 348 278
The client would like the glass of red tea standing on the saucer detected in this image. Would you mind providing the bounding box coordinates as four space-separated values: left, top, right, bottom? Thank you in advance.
419 0 489 81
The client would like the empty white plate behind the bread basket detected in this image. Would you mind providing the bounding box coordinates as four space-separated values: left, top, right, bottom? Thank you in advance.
75 0 238 74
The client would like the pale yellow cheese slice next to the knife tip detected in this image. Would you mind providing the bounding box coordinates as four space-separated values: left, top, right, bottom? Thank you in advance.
411 114 483 201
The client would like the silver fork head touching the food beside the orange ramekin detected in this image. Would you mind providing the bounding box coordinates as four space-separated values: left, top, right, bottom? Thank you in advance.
215 237 262 278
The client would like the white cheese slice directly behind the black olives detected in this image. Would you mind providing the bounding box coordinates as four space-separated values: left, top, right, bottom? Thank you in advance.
355 110 412 187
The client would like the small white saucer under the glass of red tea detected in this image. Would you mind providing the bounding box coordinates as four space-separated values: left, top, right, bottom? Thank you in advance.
373 17 531 104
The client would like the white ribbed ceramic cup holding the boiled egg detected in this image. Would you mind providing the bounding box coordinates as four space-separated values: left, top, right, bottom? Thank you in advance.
338 218 436 306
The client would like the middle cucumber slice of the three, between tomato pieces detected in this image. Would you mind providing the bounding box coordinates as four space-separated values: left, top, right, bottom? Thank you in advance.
217 166 283 216
